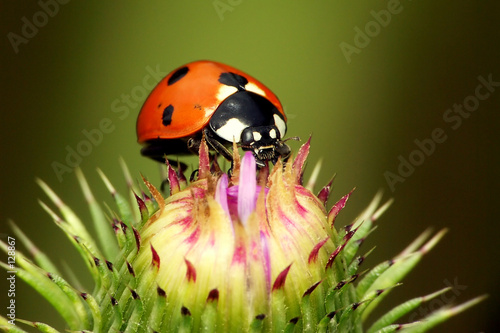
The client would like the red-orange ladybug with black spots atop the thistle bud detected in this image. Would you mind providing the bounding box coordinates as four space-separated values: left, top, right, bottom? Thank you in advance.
137 60 290 166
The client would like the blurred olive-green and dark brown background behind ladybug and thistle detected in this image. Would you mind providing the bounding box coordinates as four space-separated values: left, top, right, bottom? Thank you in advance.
0 0 500 332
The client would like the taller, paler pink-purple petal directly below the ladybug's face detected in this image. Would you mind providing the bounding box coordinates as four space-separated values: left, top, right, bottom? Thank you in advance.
238 152 257 225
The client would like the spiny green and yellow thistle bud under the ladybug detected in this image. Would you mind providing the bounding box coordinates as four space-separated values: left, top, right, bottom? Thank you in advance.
0 142 482 333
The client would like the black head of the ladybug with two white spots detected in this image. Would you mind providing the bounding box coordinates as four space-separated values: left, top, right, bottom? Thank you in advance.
240 125 290 166
